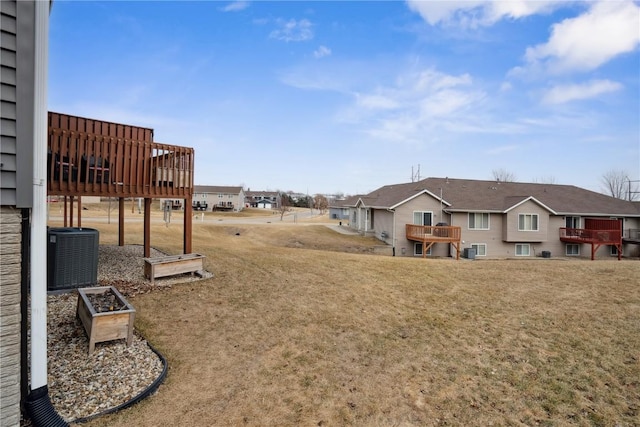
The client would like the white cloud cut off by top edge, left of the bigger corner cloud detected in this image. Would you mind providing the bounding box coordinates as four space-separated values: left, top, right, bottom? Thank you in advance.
407 0 562 28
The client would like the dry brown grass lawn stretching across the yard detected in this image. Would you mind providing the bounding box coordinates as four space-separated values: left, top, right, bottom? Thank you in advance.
66 219 640 427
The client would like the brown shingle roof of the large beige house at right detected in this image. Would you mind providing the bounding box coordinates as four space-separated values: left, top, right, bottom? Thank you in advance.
360 178 640 216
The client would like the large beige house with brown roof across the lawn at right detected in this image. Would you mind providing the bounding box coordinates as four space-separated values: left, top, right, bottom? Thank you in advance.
342 178 640 258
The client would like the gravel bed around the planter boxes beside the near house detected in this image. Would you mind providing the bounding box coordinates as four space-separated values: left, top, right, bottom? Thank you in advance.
22 245 211 426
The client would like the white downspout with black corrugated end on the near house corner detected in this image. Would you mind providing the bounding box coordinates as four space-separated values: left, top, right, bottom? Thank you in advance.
25 1 68 427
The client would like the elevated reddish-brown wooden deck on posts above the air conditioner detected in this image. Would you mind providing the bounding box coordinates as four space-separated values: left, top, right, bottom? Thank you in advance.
47 112 194 257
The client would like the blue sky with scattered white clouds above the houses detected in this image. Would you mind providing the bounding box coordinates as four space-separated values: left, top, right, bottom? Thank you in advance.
49 0 640 194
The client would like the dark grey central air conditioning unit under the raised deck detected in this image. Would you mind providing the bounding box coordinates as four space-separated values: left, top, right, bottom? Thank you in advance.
47 227 99 291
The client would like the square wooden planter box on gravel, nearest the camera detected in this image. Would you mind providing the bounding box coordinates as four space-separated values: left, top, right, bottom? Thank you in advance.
76 286 136 354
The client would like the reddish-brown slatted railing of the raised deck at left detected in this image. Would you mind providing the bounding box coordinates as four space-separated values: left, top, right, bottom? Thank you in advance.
47 128 194 199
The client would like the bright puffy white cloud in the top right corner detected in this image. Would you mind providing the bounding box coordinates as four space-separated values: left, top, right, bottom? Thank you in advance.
516 1 640 73
